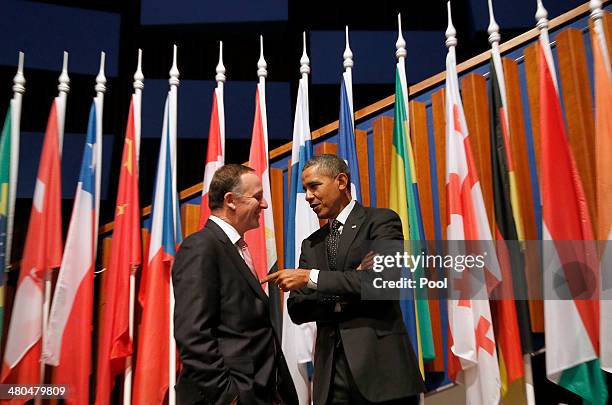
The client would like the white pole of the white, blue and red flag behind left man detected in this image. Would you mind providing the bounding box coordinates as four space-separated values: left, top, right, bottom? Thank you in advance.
168 45 179 405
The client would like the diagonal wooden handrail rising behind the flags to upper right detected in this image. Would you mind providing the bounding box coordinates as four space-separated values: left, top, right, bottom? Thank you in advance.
99 0 612 235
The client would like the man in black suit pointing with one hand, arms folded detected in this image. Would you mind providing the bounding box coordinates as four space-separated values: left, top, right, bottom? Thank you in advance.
263 155 424 405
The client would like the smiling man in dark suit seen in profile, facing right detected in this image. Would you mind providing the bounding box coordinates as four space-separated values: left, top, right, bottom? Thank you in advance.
172 164 298 405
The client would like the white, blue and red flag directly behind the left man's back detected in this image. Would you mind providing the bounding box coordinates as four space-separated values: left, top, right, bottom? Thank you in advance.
133 93 181 404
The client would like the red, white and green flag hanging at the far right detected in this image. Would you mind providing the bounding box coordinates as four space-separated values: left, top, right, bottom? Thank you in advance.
539 33 608 404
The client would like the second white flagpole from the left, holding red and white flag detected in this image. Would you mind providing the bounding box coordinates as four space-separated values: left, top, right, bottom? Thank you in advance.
40 51 70 405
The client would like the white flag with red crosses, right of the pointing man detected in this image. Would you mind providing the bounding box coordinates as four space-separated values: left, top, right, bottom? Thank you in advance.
446 28 501 404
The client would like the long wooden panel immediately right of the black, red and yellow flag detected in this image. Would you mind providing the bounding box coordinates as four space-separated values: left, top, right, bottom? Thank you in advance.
502 58 544 332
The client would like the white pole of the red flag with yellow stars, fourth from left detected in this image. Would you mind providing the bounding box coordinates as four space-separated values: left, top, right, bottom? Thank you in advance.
123 49 144 405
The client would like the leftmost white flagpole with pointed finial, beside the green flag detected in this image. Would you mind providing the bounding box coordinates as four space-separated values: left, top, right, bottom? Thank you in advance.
4 52 26 270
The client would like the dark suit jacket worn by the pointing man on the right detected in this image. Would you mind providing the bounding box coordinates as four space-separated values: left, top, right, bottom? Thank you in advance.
287 204 425 405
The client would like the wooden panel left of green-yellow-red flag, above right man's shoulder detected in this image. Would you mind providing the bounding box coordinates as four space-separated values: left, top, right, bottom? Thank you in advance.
373 116 393 208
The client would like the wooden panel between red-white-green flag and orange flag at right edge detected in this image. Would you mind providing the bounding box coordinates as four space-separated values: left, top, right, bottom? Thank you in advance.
557 28 597 223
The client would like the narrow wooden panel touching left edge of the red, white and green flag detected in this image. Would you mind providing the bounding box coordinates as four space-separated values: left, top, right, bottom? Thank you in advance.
525 41 541 178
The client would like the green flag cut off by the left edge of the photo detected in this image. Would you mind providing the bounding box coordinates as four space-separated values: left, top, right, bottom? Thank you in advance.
0 101 12 336
